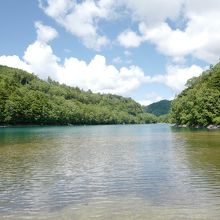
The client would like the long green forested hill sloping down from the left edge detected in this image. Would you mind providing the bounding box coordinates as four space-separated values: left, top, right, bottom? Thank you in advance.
0 66 156 125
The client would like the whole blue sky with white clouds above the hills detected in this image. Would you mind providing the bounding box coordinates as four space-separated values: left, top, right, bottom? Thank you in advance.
0 0 220 105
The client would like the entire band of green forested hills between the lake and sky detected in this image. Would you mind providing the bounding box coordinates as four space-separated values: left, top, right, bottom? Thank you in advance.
0 63 220 127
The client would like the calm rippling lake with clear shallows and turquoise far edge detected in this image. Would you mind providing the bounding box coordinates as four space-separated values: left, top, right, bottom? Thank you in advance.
0 124 220 220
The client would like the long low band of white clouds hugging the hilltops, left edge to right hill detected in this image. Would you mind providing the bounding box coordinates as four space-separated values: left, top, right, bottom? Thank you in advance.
0 24 203 97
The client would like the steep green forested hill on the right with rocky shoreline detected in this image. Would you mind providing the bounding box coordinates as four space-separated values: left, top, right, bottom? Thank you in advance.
171 63 220 126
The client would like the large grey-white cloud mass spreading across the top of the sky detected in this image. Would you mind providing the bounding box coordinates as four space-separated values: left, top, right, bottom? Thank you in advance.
38 0 220 64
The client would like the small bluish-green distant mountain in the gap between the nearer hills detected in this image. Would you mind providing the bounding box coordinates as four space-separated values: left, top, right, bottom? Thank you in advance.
144 100 171 116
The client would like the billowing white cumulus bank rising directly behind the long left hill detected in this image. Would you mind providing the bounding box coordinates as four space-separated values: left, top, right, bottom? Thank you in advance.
0 23 150 95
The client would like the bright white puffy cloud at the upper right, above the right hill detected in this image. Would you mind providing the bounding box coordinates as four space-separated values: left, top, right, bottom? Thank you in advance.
140 15 220 63
